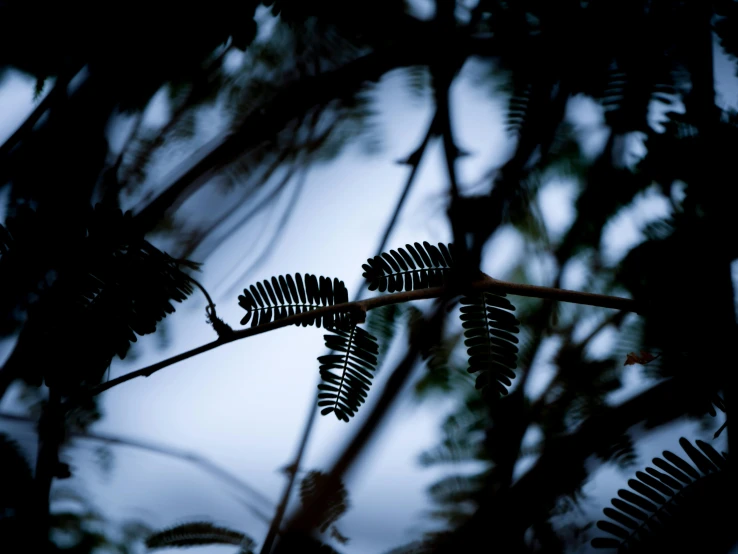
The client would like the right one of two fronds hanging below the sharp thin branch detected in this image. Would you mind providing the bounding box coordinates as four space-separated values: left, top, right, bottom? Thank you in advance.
461 292 520 395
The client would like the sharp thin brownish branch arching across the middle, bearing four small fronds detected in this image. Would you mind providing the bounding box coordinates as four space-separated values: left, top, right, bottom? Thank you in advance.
65 276 641 406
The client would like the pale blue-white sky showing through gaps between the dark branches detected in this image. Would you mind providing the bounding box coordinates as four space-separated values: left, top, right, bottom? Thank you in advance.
0 31 734 554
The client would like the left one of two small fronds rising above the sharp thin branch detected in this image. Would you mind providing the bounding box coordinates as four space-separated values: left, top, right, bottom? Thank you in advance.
238 273 349 329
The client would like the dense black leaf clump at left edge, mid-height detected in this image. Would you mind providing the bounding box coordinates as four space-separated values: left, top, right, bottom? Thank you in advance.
0 205 192 394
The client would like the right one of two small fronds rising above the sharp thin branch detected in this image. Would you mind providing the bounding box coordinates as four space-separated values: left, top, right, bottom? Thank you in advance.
362 242 454 292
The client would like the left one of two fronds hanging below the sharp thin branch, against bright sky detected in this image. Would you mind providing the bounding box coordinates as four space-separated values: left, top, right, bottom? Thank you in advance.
318 325 379 421
